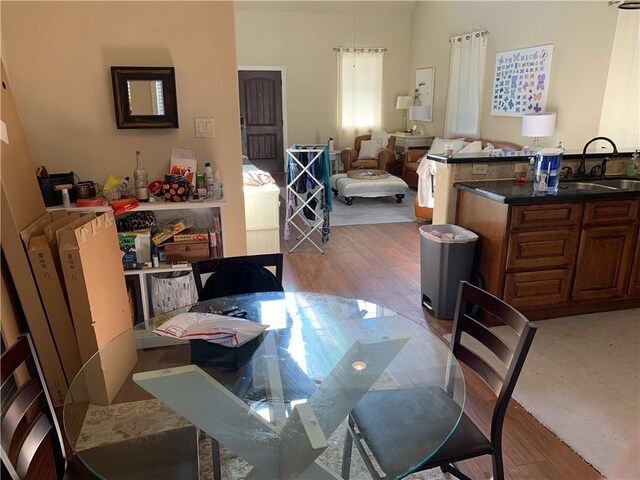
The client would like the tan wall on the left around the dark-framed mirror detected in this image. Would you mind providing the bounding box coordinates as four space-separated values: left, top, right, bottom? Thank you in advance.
2 1 246 255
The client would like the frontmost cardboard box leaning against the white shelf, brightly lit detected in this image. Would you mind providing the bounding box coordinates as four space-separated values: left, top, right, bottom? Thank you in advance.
58 212 137 405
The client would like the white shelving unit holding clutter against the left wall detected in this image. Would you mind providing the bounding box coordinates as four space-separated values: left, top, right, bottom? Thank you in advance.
47 199 227 320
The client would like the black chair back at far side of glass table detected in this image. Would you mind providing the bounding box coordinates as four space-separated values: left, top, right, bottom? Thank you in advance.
192 253 284 301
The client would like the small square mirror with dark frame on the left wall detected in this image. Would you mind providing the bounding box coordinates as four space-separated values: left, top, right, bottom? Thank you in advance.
111 67 178 128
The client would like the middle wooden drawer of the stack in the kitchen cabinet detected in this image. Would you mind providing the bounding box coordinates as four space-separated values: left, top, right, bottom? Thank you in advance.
507 228 578 269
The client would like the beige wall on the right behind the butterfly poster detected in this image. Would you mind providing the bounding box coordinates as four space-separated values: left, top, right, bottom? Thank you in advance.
407 1 620 151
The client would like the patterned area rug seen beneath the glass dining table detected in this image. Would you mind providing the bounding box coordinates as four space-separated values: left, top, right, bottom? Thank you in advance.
76 400 447 480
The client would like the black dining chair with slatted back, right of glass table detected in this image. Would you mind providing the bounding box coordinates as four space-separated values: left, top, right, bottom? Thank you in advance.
342 281 536 480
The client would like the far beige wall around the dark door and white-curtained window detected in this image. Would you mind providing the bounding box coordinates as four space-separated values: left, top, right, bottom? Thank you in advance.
236 2 413 153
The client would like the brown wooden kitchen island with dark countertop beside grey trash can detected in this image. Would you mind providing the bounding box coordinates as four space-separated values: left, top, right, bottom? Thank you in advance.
455 179 640 320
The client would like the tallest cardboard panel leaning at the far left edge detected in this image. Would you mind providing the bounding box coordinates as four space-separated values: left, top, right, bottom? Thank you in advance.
0 61 67 405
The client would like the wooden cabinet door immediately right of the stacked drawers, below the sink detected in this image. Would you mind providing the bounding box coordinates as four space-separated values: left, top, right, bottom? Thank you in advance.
572 225 635 300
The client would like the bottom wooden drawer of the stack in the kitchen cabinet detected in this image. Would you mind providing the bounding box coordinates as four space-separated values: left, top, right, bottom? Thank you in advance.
503 268 571 308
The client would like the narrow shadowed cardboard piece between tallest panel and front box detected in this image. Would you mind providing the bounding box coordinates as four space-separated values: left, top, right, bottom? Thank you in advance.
20 213 82 383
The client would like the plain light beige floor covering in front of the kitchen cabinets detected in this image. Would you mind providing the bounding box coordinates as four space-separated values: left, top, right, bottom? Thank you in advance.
452 308 640 477
